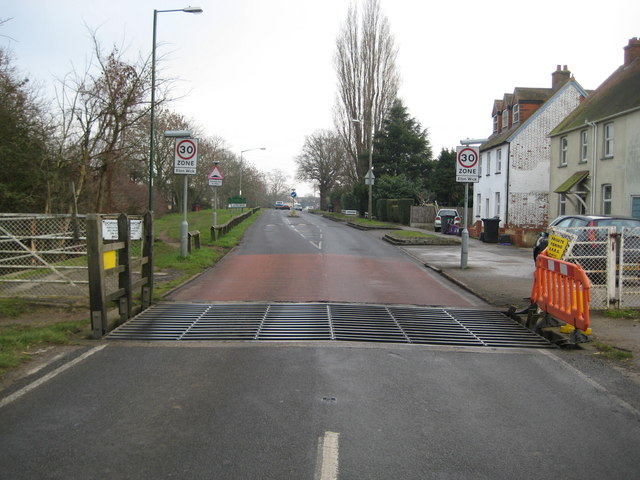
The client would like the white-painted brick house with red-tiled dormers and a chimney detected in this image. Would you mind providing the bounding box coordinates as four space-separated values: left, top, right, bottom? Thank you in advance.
473 65 587 245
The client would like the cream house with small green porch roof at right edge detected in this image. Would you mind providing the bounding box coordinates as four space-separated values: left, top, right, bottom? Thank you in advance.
549 38 640 218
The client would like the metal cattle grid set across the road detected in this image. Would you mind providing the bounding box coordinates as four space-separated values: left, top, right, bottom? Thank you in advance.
107 303 552 348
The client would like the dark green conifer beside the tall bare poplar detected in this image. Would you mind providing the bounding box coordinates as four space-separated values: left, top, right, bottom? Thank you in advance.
373 100 433 185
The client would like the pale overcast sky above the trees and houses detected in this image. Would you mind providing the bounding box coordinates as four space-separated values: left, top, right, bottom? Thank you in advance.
0 0 640 195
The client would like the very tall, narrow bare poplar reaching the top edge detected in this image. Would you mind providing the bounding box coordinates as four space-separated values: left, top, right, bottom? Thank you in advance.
334 0 400 184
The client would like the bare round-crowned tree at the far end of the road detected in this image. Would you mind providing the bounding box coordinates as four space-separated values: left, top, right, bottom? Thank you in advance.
295 130 348 210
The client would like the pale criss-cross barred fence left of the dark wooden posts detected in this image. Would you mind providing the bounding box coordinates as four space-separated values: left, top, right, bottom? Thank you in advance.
0 214 89 301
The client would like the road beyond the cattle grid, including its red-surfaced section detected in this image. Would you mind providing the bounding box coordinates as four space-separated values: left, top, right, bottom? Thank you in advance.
169 210 482 307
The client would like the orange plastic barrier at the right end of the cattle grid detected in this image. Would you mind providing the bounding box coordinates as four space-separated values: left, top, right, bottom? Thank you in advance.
531 250 591 332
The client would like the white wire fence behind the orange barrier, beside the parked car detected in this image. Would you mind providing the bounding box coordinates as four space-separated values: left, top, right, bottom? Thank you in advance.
550 227 640 309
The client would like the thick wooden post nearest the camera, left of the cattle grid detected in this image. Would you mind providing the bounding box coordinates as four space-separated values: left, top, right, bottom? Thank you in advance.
86 214 107 339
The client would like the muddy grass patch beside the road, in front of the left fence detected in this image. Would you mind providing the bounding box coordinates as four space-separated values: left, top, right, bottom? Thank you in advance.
0 320 90 375
